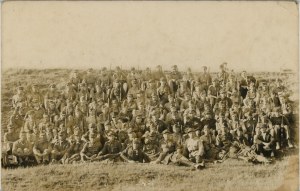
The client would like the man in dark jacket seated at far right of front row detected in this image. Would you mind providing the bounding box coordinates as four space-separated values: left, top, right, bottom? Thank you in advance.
254 125 275 157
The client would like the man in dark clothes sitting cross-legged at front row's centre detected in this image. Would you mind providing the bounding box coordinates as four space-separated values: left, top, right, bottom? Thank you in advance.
120 139 151 163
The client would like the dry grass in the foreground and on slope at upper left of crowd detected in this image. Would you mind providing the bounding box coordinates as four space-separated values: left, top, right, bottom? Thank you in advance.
1 70 299 191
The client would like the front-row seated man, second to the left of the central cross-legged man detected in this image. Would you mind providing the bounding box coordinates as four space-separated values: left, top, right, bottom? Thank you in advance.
80 132 103 162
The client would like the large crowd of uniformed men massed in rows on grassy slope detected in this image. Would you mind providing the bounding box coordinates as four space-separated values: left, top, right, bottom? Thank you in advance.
2 63 294 169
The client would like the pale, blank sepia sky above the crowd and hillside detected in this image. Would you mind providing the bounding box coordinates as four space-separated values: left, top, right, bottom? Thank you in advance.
1 1 298 71
